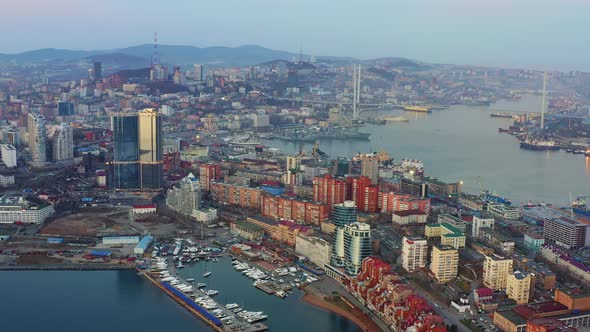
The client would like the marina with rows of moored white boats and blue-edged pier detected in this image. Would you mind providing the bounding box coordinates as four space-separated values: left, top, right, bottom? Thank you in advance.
139 239 340 332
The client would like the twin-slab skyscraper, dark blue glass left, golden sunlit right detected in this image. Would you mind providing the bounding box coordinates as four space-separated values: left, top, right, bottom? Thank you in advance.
111 108 162 190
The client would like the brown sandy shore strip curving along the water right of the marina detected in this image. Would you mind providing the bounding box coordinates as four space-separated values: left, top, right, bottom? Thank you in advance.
302 287 381 332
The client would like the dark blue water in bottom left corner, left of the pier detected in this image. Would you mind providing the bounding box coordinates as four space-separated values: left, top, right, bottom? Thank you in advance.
0 270 210 332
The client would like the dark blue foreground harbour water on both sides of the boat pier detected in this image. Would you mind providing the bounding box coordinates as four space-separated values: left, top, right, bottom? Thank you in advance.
0 264 360 332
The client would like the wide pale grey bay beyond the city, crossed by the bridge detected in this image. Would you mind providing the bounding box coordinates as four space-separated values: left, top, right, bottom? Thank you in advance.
264 95 590 205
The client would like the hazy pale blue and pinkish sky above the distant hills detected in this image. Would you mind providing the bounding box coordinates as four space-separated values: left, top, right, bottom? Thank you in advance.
0 0 590 70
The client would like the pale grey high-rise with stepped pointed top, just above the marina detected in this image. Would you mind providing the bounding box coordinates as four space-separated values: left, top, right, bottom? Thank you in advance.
166 173 201 216
